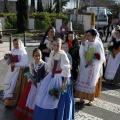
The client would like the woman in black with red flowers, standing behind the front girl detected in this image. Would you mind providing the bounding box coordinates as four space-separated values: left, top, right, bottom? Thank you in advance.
66 31 80 80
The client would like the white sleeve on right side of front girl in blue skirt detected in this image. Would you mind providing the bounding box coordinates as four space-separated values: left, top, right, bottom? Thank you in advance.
60 53 71 77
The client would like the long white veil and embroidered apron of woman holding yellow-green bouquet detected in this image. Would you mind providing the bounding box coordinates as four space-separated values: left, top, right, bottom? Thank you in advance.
75 40 105 94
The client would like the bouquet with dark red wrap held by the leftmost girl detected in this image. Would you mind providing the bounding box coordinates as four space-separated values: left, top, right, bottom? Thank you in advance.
4 54 19 72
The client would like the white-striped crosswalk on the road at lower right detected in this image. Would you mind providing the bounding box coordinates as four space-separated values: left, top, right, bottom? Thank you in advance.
75 84 120 120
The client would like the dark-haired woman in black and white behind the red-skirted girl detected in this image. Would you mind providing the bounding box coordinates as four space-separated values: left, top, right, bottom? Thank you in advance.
38 26 55 62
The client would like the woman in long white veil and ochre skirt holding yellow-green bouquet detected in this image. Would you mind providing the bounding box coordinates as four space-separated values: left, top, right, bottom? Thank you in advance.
75 29 105 105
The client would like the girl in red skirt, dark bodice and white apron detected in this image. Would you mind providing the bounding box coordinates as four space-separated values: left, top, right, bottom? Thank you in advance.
15 48 46 120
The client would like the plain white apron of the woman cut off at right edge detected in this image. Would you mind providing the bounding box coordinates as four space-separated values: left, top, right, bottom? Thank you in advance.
105 52 120 80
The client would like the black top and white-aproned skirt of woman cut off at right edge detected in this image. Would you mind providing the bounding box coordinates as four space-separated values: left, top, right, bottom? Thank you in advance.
105 38 120 85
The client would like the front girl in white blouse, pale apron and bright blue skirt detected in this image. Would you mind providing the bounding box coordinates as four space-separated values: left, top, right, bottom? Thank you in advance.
33 38 74 120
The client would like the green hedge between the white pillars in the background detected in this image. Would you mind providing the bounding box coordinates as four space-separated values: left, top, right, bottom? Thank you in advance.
3 12 68 30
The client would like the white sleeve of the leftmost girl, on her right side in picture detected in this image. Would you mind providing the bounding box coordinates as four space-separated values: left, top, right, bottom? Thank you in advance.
15 52 29 67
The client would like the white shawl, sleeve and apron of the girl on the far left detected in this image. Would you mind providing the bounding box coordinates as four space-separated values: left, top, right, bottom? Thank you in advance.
4 49 28 98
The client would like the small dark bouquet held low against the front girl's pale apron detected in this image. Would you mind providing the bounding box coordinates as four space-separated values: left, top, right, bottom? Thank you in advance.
49 81 76 99
